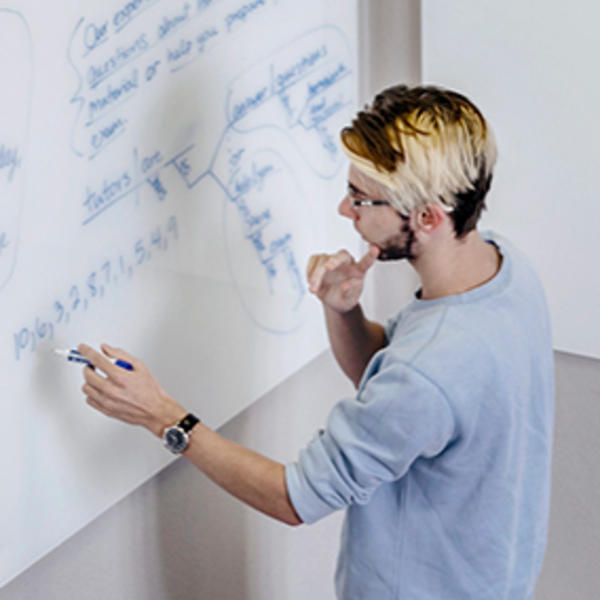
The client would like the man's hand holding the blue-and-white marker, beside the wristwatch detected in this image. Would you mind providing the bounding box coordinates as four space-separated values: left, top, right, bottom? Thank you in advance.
77 344 186 437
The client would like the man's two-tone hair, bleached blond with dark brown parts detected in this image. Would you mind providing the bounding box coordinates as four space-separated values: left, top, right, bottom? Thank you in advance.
341 85 497 237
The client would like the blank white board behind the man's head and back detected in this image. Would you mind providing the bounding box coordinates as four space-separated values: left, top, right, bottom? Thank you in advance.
422 0 600 358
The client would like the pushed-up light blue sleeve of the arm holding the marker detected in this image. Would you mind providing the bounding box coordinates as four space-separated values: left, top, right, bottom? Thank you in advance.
285 360 454 523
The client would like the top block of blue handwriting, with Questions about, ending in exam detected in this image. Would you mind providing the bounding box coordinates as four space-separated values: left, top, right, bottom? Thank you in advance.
68 0 278 159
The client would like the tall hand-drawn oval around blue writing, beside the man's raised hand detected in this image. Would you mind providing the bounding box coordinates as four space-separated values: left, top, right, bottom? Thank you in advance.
224 148 308 334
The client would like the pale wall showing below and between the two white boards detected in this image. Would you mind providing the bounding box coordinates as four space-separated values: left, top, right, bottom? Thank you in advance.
0 0 600 600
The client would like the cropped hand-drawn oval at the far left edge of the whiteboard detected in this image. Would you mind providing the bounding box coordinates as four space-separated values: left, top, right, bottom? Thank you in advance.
0 8 32 290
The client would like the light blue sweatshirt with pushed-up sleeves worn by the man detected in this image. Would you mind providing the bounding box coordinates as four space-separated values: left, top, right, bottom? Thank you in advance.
286 234 554 600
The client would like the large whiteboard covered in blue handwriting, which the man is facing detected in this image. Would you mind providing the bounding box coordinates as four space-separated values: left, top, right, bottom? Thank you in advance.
0 0 359 585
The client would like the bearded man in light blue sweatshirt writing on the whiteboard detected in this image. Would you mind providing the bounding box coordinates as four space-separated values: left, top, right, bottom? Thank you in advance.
79 86 553 600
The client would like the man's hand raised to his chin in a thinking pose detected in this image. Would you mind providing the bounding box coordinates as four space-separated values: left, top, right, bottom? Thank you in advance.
306 245 379 313
